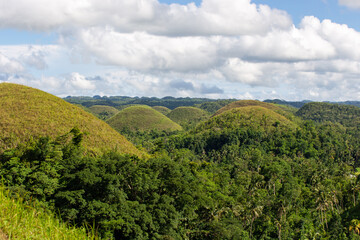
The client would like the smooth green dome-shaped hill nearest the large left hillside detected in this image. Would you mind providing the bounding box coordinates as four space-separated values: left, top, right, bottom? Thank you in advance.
107 105 182 131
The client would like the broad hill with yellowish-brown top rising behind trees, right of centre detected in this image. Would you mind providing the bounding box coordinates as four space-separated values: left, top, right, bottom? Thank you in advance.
196 106 297 132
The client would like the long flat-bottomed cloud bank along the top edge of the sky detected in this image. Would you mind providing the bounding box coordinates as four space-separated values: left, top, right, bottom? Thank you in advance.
0 0 291 35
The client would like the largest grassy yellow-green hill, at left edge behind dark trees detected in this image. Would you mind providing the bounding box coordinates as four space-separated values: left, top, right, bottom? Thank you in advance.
0 83 142 155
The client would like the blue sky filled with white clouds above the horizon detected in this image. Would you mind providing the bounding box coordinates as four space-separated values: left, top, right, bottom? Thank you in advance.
0 0 360 101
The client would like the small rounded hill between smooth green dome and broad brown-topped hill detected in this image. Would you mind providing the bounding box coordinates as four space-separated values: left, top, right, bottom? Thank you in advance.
167 107 210 126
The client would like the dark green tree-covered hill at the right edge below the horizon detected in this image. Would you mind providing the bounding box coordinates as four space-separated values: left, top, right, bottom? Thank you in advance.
296 102 360 127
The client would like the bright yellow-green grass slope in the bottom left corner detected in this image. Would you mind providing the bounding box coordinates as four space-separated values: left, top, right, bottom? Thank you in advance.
0 186 97 240
